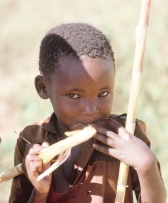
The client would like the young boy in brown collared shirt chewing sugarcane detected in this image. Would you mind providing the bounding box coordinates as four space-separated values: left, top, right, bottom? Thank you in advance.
9 23 166 203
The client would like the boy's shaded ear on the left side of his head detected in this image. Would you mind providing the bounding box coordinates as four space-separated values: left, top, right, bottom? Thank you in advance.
34 75 49 99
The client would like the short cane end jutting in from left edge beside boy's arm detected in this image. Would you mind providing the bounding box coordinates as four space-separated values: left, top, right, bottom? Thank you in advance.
0 163 24 183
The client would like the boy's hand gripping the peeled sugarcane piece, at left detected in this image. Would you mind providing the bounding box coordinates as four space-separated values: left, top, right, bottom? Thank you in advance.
23 142 52 198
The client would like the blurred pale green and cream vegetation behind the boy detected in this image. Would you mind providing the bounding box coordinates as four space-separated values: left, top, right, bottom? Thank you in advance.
0 0 168 203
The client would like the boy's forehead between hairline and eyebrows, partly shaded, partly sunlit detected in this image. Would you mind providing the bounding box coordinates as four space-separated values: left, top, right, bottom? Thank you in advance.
52 56 115 86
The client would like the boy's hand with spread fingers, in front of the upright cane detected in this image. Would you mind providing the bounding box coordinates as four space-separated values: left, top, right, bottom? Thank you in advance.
92 119 155 174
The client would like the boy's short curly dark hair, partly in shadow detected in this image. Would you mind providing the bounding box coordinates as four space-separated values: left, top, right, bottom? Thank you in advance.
39 23 114 77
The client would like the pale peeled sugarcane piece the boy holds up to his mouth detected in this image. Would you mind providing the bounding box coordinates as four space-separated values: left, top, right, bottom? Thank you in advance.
39 126 96 164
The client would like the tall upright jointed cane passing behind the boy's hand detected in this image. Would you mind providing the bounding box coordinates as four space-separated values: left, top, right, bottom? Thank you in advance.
115 0 151 203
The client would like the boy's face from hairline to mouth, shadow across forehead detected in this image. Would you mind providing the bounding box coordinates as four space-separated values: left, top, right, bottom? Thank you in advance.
47 56 115 129
